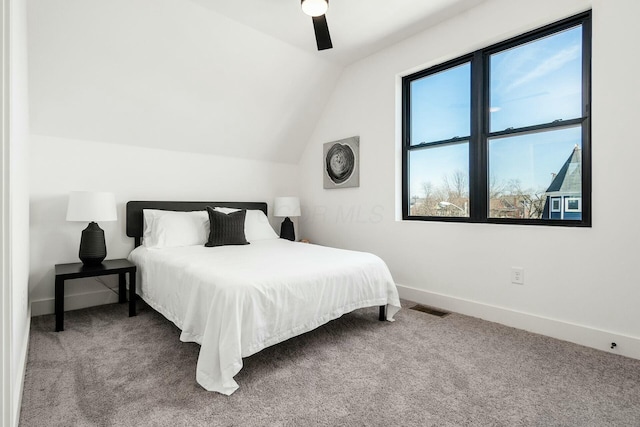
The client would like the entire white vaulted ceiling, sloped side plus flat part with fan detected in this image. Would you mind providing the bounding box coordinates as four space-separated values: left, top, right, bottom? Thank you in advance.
28 0 483 163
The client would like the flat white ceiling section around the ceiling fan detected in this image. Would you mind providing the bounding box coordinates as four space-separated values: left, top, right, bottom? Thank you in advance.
192 0 484 65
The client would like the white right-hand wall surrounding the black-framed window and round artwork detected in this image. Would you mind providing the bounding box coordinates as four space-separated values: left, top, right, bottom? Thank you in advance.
300 0 640 358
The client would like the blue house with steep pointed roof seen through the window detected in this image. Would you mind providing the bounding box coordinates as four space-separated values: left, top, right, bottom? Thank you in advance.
542 145 582 220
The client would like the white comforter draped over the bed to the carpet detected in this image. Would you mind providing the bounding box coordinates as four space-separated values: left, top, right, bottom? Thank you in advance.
129 239 400 395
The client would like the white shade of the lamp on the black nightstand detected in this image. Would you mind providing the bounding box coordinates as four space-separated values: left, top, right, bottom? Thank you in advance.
67 191 118 222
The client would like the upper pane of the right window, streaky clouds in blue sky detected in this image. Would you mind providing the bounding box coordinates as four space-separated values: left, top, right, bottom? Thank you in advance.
489 26 582 132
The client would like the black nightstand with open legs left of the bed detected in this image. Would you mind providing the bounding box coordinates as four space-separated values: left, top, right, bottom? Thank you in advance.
56 259 136 332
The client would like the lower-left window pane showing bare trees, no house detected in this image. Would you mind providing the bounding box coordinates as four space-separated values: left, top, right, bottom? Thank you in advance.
408 142 469 217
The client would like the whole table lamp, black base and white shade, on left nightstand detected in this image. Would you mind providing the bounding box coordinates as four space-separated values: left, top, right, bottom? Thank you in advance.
67 191 118 265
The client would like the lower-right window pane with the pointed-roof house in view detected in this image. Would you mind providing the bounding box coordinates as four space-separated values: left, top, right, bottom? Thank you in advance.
489 126 582 220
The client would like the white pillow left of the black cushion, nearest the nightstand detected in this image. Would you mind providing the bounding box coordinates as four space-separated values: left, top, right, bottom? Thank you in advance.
142 209 209 248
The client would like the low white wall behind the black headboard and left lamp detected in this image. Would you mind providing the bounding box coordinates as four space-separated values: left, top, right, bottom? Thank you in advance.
29 135 298 316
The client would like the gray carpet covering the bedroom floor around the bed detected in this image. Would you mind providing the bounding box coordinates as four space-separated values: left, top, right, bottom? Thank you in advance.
20 302 640 426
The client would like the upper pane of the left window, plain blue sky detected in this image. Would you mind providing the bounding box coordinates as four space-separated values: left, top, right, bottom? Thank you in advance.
410 63 471 145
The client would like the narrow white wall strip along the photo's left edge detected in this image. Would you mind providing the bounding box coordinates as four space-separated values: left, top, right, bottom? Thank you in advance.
0 0 30 426
